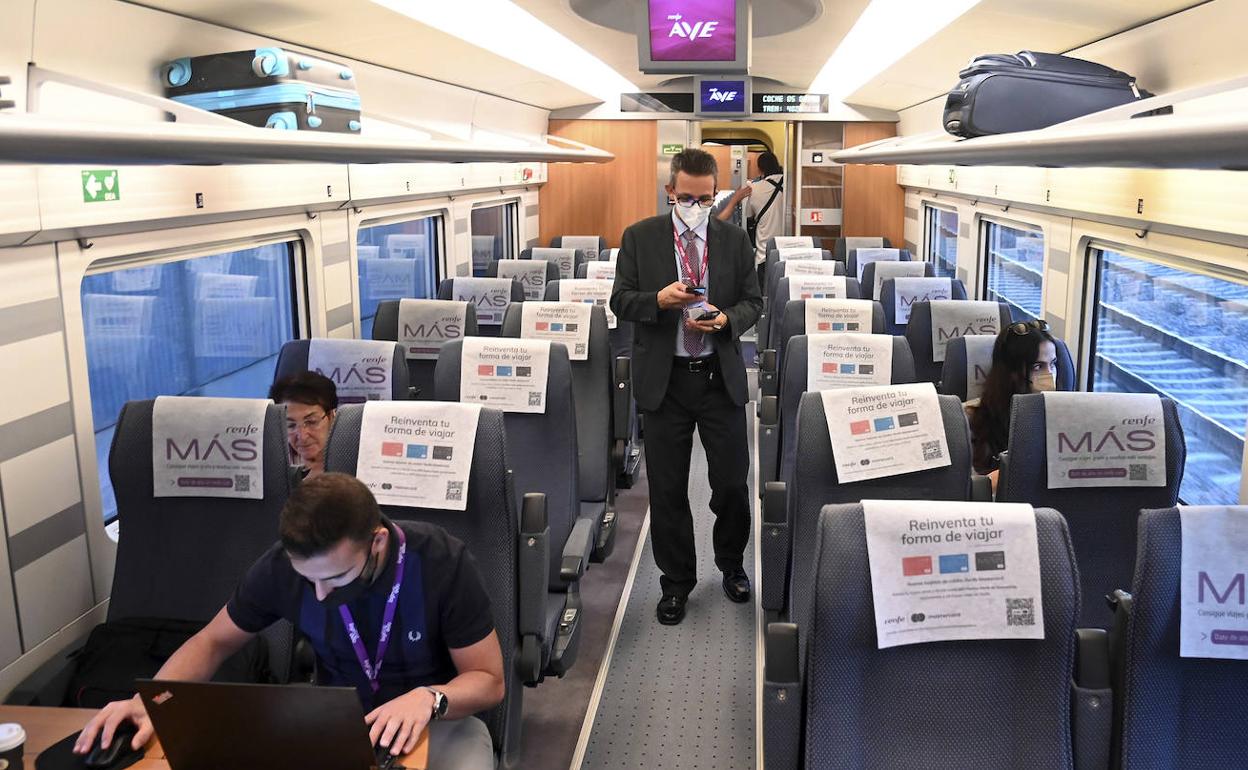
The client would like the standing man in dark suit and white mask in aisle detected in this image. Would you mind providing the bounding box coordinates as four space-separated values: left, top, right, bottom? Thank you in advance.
610 150 763 625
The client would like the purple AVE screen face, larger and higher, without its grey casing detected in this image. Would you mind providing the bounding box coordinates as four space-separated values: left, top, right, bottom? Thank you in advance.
649 0 736 61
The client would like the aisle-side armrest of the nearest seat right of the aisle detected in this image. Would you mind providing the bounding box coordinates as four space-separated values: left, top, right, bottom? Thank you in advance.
763 623 802 770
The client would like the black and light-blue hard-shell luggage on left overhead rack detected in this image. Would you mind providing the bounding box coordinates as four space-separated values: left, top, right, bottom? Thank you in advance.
161 47 361 134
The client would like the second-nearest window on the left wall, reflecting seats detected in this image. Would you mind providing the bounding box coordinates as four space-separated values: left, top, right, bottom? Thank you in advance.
356 217 441 339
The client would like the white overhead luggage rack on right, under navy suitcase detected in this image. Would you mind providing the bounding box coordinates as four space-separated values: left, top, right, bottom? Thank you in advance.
832 77 1248 171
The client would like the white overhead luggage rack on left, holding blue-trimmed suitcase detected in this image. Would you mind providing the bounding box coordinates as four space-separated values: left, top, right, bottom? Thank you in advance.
0 67 615 166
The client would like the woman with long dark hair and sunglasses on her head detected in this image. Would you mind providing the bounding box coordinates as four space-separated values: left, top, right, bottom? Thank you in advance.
966 321 1057 479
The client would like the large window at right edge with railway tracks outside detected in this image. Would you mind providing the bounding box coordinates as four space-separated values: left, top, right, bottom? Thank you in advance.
1090 248 1248 505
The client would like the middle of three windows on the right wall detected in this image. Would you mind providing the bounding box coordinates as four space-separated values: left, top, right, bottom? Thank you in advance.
983 222 1045 321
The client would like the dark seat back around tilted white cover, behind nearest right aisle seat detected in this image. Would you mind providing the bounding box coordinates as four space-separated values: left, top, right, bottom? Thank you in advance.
789 393 971 624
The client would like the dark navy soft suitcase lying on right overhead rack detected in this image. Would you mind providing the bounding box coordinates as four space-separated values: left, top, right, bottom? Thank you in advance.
943 51 1152 137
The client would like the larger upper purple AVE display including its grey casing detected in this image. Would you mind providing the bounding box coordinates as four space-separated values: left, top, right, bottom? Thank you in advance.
638 0 750 75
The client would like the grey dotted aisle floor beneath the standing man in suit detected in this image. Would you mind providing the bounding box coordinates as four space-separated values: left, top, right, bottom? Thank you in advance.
572 416 760 770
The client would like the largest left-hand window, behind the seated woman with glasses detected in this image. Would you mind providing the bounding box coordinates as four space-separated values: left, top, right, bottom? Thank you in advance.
81 243 300 523
